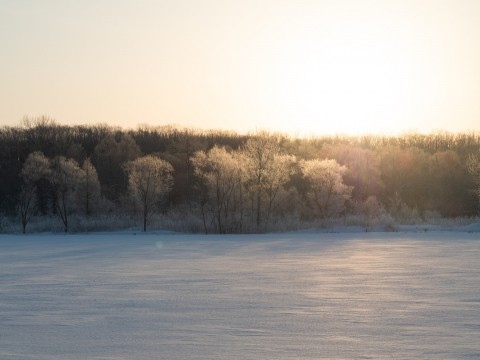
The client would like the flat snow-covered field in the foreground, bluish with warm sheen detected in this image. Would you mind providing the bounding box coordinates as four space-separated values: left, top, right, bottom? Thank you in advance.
0 232 480 360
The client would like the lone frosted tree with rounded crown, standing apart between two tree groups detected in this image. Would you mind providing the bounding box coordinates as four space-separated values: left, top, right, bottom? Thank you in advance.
125 155 173 231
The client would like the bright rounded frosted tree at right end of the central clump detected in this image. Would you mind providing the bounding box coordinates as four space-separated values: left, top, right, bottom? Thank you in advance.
300 159 352 218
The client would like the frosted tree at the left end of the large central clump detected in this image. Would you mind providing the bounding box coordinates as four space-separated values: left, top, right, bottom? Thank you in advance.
191 146 242 233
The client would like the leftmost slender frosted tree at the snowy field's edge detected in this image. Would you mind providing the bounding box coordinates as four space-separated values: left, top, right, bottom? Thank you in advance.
17 151 50 233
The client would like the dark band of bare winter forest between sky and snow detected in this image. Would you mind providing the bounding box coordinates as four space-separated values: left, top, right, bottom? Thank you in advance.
0 116 480 233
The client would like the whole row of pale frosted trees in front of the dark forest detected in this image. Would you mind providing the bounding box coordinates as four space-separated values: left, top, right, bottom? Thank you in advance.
17 135 352 233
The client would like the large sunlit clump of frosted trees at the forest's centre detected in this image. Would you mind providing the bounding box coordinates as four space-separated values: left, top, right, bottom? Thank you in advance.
191 136 352 233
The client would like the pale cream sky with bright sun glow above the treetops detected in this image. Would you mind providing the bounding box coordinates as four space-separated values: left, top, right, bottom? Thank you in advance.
0 0 480 135
